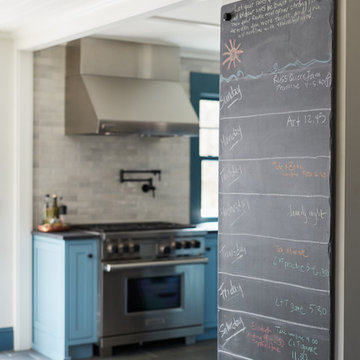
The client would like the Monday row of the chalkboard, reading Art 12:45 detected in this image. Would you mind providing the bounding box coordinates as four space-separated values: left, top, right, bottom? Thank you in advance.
220 110 330 160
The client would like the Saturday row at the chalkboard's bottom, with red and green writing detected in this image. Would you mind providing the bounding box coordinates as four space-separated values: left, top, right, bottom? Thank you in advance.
218 310 330 360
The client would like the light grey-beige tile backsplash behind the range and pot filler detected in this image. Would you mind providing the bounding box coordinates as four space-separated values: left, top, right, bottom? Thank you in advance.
33 46 219 226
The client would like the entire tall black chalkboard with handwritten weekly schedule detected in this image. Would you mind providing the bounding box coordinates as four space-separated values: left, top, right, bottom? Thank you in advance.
218 0 334 360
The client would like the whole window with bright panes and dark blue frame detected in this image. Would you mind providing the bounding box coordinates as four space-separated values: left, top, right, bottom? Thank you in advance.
190 73 219 223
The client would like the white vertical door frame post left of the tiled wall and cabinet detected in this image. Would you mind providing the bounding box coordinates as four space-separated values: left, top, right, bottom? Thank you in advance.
13 49 34 350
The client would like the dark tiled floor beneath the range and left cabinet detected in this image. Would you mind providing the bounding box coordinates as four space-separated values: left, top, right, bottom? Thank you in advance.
0 340 216 360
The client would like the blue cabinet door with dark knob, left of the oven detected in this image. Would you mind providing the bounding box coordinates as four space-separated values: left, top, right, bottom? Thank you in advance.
66 240 98 344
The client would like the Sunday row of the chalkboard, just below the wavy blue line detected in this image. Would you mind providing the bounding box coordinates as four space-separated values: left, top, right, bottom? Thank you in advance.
220 63 332 116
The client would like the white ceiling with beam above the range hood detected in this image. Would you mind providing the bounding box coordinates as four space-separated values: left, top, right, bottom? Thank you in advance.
0 0 223 54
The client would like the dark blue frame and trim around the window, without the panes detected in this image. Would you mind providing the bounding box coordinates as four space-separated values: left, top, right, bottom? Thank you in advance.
190 72 219 224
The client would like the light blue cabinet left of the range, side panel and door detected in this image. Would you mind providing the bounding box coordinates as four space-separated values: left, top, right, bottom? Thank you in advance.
33 235 98 360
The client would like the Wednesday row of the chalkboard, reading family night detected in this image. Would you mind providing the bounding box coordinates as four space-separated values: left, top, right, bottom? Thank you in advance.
219 195 330 242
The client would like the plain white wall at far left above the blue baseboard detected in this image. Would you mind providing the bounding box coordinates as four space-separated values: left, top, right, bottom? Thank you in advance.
0 37 15 328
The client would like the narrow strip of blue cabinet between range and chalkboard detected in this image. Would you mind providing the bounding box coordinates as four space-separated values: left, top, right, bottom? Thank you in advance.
197 233 218 340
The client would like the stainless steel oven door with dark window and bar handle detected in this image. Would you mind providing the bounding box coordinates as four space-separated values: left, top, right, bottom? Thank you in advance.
101 258 207 337
